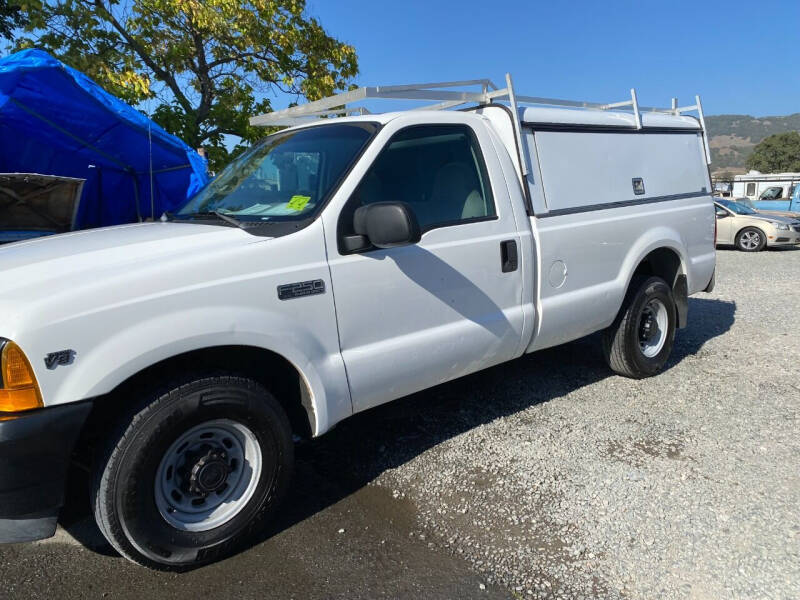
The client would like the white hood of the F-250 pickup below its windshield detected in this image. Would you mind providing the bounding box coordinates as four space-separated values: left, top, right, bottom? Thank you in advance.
0 222 265 320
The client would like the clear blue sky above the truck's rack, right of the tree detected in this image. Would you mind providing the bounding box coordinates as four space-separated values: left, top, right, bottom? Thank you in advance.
302 0 800 116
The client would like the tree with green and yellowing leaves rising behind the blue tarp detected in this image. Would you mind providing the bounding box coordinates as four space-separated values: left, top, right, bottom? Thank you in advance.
16 0 358 169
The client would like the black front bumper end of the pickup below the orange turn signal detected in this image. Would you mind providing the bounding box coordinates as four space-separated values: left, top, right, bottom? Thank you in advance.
0 401 92 524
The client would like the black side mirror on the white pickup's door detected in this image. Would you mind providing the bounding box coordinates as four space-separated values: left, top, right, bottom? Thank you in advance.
353 202 421 248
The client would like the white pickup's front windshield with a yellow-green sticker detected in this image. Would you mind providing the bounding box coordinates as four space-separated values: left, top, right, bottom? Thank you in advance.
177 123 377 223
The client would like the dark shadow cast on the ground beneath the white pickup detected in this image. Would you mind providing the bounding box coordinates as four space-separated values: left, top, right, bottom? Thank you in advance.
61 298 736 554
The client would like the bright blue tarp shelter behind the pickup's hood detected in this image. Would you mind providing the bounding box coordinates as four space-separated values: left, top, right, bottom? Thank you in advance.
0 50 209 229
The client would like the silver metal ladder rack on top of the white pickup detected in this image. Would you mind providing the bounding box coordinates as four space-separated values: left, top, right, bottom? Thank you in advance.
250 74 711 164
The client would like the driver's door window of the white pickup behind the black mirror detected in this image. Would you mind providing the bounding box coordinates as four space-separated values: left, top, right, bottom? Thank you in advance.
341 125 497 244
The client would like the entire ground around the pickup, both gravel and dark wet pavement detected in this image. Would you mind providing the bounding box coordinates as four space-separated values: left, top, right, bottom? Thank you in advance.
0 250 800 599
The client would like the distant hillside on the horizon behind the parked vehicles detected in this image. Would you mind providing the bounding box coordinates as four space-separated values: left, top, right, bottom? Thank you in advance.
706 113 800 174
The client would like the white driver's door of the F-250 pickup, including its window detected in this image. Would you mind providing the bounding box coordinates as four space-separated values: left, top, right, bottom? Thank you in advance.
324 124 523 411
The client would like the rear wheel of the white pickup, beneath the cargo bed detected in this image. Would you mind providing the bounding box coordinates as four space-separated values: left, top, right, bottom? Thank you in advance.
603 276 676 379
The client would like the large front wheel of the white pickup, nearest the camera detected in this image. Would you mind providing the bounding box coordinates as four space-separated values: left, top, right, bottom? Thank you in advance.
91 377 294 569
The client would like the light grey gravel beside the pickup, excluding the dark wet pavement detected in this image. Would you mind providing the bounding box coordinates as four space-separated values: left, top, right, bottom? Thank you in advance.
320 250 800 599
